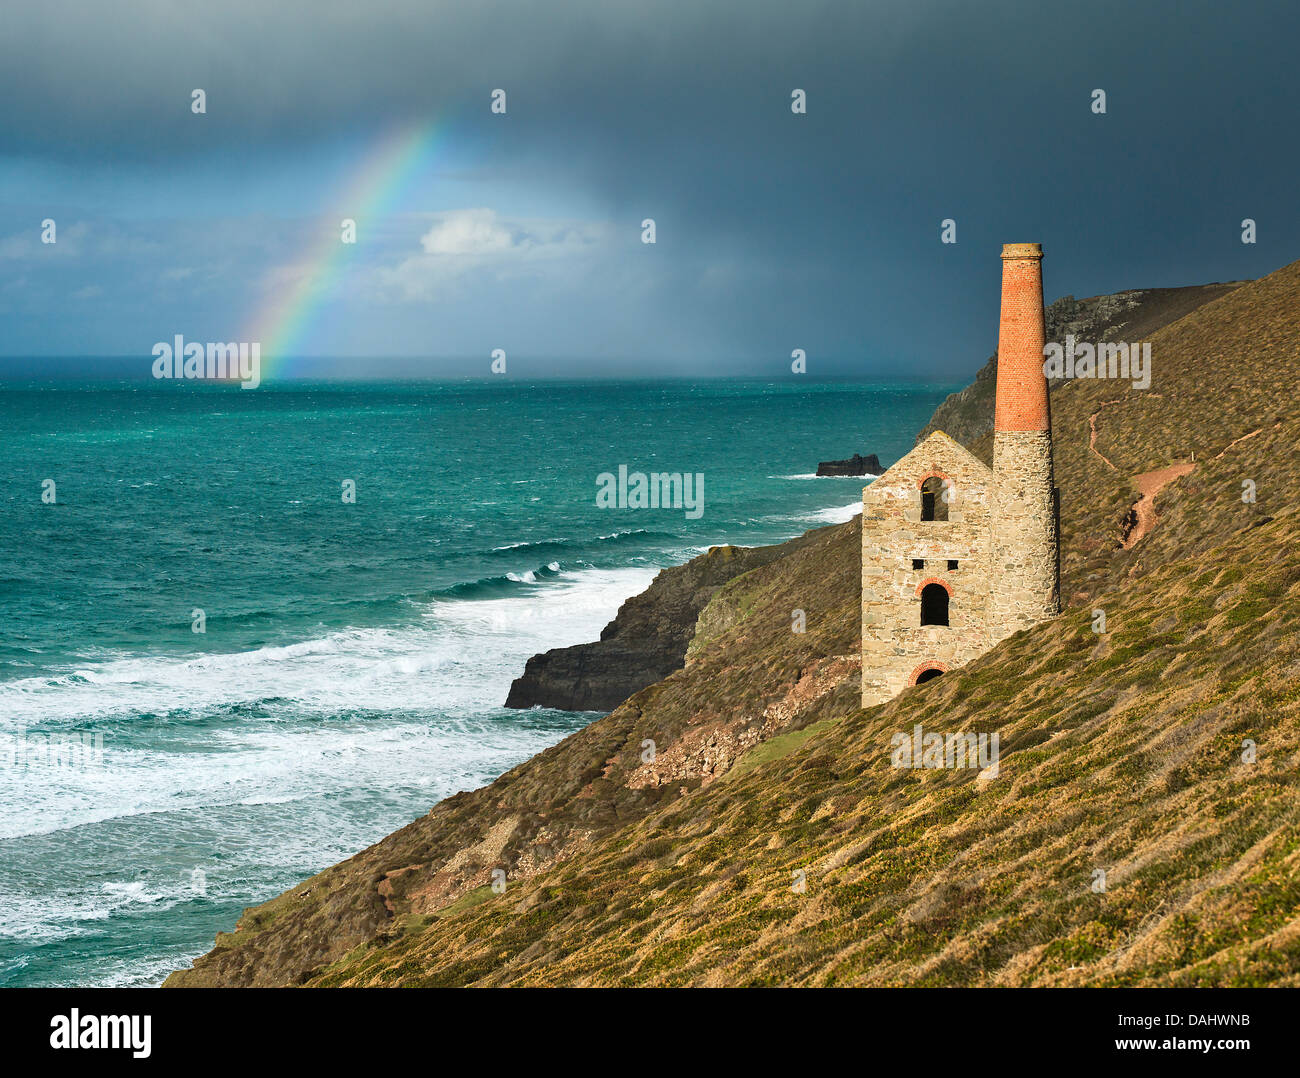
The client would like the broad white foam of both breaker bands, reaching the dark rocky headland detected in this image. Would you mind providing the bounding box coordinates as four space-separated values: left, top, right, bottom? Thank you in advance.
0 568 654 840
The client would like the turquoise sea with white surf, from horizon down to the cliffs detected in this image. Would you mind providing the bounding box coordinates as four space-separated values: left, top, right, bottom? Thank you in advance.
0 380 953 986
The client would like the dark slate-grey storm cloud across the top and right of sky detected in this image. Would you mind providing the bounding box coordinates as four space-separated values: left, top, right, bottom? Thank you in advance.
0 0 1300 376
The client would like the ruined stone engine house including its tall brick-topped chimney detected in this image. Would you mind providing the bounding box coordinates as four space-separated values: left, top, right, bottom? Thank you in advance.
862 243 1060 707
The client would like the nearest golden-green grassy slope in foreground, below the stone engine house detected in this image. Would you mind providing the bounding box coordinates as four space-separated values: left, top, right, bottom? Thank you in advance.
304 520 1300 984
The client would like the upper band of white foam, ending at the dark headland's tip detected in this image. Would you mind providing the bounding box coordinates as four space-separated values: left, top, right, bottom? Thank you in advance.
0 563 654 732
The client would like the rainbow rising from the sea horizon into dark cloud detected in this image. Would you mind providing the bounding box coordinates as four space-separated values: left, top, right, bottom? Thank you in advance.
241 122 441 378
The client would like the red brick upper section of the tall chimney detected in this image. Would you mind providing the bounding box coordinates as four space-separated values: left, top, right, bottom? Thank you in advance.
993 243 1048 430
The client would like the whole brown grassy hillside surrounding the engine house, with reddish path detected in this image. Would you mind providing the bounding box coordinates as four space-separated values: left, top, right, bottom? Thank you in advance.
169 263 1300 984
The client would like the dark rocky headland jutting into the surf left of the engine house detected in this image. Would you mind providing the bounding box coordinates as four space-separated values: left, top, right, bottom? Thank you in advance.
506 536 806 711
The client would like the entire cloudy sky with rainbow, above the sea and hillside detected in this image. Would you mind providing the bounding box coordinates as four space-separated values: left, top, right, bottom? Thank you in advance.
0 0 1300 381
